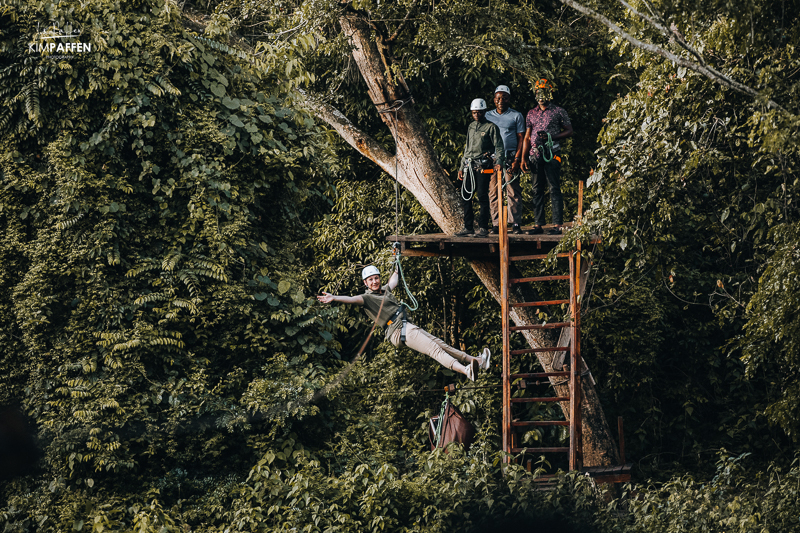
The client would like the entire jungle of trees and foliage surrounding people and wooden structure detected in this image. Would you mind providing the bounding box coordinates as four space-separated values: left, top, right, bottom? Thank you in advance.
0 0 800 532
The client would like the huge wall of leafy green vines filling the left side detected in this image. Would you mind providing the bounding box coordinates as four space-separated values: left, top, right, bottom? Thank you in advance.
0 0 338 531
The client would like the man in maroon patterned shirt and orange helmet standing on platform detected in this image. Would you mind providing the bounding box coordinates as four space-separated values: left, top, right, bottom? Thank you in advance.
522 79 573 235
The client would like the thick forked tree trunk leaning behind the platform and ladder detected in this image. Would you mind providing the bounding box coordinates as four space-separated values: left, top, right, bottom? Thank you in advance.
309 15 618 466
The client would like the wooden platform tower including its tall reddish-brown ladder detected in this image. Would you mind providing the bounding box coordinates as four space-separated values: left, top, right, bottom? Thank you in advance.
387 180 632 483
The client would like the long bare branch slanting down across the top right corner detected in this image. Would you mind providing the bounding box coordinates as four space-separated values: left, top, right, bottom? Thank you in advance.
560 0 789 113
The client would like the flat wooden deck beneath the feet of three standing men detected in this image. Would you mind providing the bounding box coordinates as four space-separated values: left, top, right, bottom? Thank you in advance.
386 222 600 259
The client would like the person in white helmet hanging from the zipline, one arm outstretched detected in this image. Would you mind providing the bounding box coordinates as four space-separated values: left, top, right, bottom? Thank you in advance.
317 266 492 381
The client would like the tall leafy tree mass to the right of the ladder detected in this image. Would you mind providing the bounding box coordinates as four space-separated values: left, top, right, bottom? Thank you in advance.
586 2 800 455
